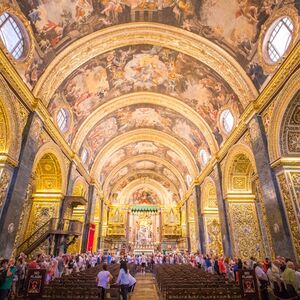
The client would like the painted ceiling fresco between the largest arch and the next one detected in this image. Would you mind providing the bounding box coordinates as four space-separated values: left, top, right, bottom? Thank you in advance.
48 45 242 143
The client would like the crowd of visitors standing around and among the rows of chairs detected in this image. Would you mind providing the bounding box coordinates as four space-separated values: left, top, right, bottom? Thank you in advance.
0 251 300 300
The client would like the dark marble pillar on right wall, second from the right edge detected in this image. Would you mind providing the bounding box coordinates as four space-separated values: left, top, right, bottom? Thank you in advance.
214 163 232 257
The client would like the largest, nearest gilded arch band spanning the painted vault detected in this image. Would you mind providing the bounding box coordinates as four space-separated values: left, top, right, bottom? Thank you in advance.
33 22 257 107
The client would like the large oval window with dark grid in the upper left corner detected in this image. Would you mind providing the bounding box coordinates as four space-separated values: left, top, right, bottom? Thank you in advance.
0 12 24 59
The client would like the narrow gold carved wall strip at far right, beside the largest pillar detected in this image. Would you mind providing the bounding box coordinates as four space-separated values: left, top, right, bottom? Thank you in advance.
278 173 300 259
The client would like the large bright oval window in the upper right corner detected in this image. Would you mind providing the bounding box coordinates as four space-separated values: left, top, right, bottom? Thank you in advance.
267 17 294 63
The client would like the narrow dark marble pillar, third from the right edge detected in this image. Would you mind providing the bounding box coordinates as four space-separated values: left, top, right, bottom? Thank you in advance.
193 185 206 254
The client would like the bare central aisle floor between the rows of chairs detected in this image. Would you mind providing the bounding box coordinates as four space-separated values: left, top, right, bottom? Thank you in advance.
130 273 159 300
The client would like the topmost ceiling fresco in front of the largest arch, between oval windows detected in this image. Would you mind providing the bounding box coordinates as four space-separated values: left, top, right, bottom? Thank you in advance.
17 0 300 88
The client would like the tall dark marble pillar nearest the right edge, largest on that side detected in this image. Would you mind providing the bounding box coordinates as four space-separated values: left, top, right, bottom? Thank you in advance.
249 115 296 259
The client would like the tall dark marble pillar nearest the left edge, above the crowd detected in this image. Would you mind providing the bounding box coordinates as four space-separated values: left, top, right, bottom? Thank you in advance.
0 112 43 257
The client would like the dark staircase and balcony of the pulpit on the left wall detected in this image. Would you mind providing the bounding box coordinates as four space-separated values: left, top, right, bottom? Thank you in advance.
17 218 82 255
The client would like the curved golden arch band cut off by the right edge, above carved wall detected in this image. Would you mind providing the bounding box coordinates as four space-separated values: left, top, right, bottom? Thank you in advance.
268 70 300 163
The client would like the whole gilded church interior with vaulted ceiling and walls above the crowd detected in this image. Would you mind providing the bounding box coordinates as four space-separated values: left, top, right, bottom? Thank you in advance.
0 0 300 262
